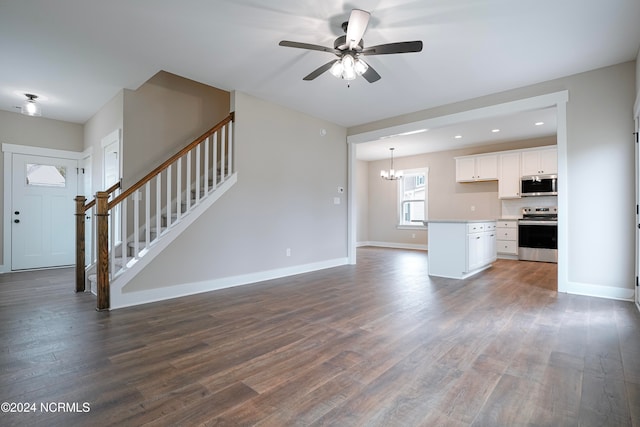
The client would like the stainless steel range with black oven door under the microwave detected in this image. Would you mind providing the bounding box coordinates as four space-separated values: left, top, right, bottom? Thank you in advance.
518 206 558 263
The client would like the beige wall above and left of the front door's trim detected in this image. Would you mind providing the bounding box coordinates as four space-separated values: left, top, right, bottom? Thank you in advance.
0 111 83 271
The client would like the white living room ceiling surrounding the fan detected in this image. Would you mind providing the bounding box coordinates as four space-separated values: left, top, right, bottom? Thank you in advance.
0 0 640 158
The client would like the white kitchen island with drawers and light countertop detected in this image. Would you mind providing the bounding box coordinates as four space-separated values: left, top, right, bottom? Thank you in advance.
427 220 497 279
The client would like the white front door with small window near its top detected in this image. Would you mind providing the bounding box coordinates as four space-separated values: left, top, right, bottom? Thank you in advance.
11 154 78 270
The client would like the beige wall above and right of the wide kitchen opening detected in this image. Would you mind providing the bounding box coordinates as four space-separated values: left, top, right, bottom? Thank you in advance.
348 61 636 294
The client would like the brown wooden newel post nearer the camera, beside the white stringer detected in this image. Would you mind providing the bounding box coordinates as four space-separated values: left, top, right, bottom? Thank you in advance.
96 191 111 311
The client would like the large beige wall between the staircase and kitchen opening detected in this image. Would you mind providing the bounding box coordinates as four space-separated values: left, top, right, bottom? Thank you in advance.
124 92 347 292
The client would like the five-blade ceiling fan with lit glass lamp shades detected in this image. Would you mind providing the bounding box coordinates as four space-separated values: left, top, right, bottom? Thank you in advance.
279 9 422 83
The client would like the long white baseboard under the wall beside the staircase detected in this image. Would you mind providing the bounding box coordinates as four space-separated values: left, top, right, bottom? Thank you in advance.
111 258 348 310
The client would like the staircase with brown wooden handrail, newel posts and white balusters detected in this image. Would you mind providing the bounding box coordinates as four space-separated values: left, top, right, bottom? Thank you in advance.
76 113 237 310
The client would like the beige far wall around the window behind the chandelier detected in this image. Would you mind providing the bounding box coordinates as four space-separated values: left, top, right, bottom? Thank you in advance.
357 137 556 245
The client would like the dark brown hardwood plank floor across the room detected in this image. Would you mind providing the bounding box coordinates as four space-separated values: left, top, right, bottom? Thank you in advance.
0 248 640 427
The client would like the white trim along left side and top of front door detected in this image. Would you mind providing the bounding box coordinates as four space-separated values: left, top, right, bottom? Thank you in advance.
0 143 92 273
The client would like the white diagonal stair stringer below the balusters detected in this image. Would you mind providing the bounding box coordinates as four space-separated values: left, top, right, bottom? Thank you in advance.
109 172 238 310
